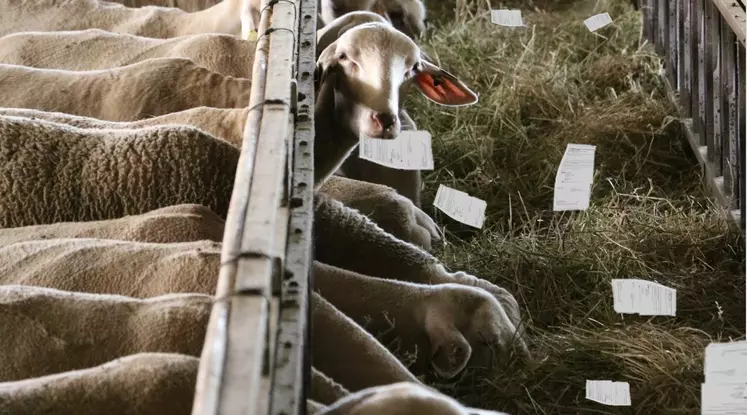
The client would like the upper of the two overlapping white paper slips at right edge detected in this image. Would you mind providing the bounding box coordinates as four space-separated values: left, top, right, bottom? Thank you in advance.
703 340 747 383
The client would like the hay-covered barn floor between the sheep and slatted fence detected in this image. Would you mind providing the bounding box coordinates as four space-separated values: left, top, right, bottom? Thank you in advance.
407 0 745 415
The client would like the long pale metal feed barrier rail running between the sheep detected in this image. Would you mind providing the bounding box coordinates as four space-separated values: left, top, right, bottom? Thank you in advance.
192 0 317 415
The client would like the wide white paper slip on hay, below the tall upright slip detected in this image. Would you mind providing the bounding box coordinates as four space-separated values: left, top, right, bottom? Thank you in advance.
612 278 677 316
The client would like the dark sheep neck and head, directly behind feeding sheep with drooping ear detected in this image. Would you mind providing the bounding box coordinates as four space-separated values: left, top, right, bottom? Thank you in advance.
314 193 521 338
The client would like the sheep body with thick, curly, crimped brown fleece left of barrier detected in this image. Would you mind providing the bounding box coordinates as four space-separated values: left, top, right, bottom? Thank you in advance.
0 116 239 228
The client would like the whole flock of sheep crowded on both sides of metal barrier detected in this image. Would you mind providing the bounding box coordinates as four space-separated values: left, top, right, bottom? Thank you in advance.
0 0 528 415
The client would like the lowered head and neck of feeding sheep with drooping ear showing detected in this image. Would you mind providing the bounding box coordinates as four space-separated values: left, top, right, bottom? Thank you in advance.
314 263 528 378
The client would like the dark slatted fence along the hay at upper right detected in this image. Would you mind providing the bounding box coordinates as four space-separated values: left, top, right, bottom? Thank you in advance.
639 0 746 230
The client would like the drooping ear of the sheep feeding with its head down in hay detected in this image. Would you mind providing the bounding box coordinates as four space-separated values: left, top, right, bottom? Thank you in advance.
425 316 472 379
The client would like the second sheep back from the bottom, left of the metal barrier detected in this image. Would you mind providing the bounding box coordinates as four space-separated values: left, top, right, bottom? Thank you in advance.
0 285 212 382
